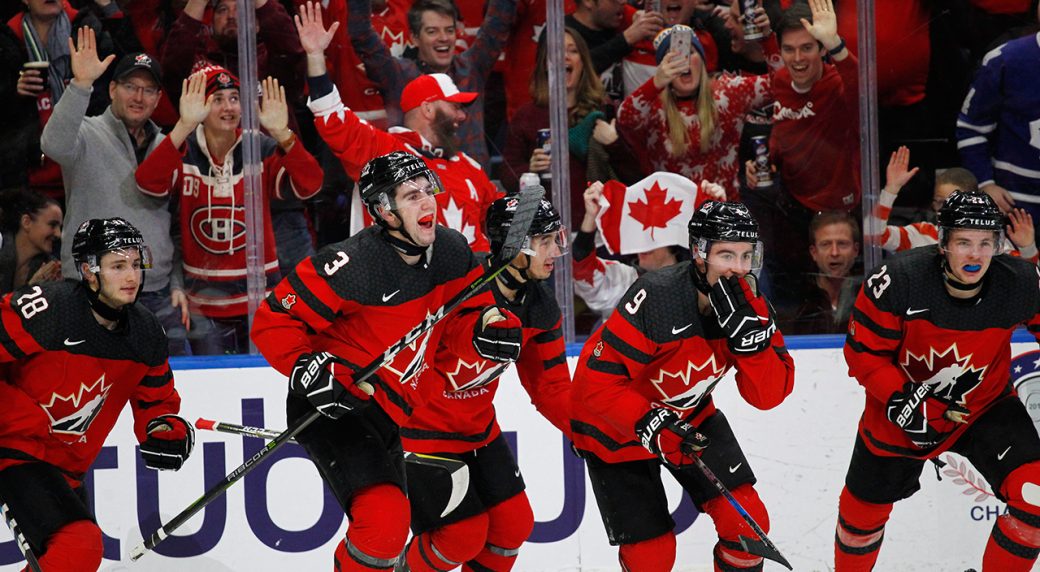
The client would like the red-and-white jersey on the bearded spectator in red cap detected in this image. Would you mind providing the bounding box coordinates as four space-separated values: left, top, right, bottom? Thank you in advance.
308 83 500 252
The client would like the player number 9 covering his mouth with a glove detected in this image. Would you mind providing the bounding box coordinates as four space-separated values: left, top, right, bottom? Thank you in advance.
571 201 795 572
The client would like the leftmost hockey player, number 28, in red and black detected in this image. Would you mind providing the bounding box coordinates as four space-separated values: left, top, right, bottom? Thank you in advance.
0 218 194 572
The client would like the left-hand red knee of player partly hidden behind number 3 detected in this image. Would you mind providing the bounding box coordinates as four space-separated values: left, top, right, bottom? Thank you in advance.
408 513 488 572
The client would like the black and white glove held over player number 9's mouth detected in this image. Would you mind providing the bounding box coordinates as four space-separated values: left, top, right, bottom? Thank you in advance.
708 276 777 356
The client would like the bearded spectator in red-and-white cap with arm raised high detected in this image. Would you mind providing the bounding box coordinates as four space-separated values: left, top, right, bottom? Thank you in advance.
296 2 499 252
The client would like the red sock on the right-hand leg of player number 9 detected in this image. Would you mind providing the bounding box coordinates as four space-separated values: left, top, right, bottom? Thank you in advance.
701 485 770 571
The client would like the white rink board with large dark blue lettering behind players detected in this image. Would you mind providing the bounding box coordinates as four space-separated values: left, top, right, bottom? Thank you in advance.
0 343 1040 572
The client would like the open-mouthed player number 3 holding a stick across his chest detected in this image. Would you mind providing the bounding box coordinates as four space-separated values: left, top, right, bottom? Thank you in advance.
253 152 521 571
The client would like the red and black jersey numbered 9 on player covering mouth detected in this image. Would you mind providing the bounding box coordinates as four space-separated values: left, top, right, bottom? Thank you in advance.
571 261 795 463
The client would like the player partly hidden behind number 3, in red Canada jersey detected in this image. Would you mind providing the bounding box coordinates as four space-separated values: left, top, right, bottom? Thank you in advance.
400 199 571 572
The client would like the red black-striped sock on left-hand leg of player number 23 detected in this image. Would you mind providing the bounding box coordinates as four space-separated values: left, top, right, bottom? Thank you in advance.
834 488 892 572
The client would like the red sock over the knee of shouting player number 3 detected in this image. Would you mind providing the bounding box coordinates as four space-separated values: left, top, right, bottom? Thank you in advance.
337 484 411 570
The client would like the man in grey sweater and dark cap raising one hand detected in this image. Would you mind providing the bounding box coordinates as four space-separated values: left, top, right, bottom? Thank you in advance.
40 28 188 356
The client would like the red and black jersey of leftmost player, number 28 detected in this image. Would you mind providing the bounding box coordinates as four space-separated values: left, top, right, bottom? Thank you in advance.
0 281 180 485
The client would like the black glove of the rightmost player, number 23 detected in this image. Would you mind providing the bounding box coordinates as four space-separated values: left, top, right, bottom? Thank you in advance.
886 382 968 448
